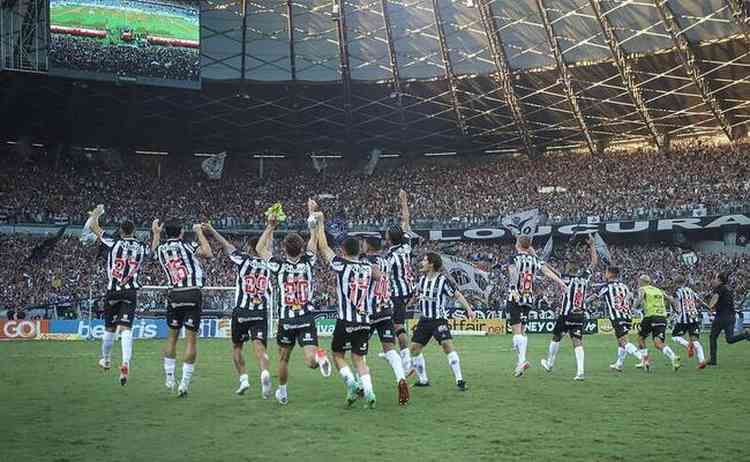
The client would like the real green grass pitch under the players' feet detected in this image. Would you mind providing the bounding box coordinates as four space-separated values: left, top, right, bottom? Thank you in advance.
0 336 750 462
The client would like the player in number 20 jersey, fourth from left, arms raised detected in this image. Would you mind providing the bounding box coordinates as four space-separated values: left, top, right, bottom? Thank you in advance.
257 200 331 406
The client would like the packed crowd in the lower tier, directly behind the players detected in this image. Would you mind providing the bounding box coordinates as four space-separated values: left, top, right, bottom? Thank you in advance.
0 235 750 312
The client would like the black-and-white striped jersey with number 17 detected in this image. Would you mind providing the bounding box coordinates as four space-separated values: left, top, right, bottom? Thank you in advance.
331 256 375 324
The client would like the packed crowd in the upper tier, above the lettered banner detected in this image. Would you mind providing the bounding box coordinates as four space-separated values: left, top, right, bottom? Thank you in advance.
0 139 750 227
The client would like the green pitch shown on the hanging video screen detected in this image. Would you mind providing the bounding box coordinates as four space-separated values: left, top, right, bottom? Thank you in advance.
50 5 200 41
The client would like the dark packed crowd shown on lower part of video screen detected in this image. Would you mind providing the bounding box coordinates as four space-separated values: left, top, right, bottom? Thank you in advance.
49 34 200 81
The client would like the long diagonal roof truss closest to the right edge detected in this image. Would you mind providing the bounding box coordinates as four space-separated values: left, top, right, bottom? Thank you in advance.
653 0 734 144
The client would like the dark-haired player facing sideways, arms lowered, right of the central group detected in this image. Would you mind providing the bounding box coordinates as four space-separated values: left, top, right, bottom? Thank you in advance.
411 252 474 391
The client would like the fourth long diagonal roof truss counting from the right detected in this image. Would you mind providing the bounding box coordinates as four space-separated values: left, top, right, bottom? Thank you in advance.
479 0 537 157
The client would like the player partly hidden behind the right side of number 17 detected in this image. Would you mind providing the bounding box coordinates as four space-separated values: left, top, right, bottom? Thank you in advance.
365 236 409 406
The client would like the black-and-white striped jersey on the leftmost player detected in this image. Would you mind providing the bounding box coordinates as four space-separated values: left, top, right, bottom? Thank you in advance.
101 234 150 291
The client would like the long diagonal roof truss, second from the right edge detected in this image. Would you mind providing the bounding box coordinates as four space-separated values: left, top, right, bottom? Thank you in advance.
589 0 665 151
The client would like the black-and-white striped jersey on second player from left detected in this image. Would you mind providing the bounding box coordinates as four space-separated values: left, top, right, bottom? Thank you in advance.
156 239 206 289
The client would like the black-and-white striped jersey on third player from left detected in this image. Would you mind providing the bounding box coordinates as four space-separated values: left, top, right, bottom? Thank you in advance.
229 250 279 320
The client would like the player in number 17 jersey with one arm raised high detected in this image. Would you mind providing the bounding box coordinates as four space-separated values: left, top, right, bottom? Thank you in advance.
315 213 383 409
